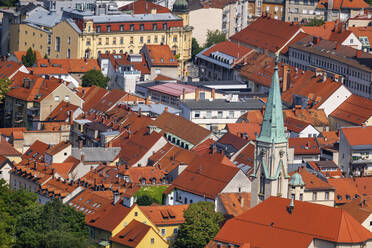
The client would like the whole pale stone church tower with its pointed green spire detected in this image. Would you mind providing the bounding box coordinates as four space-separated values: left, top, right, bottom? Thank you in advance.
250 57 289 207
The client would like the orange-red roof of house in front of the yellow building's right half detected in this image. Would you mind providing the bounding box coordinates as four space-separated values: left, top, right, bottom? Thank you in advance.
144 44 178 67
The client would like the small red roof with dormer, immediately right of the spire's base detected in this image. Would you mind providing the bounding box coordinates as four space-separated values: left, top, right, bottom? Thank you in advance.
288 137 320 155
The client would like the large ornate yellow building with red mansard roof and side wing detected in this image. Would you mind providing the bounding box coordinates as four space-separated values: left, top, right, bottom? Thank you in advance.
10 8 192 76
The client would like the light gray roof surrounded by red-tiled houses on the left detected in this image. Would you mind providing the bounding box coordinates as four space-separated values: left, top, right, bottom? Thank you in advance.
71 147 121 162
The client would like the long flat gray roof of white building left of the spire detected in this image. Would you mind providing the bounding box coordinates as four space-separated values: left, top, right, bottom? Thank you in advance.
182 98 265 110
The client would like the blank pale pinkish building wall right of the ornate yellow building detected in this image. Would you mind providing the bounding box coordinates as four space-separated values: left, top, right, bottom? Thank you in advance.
190 8 222 46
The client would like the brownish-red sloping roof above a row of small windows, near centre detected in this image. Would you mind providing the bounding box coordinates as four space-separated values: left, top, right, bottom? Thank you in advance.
151 111 211 145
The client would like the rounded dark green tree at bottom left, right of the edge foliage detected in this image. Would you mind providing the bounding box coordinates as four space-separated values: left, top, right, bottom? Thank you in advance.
15 200 89 248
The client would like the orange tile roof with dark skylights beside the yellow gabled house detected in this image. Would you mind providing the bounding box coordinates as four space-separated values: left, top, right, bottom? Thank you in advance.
140 205 189 226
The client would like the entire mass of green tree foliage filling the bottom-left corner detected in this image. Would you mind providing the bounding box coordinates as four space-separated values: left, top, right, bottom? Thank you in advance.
0 179 90 248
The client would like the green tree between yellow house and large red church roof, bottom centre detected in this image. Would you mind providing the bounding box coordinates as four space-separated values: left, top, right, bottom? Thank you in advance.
173 202 224 248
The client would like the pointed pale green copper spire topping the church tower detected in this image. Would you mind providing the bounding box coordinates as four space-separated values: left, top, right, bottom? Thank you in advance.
257 56 287 143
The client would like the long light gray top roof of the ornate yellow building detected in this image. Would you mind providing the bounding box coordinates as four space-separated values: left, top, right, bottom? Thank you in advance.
84 13 182 23
